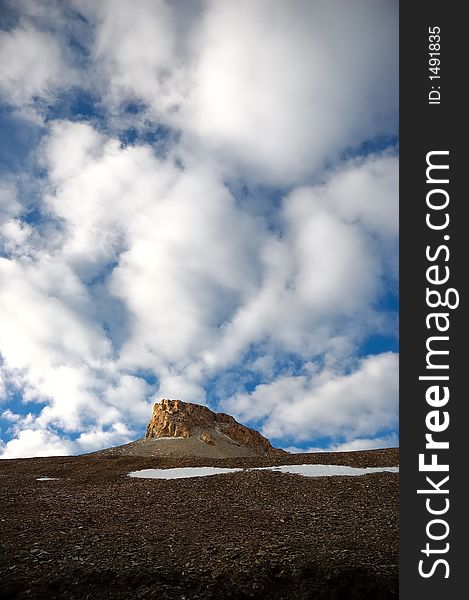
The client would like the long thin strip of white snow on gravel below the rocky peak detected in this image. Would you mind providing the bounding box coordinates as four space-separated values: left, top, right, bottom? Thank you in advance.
128 465 399 479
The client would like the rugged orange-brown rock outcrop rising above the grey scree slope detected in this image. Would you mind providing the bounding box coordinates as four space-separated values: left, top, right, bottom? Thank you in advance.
145 399 283 455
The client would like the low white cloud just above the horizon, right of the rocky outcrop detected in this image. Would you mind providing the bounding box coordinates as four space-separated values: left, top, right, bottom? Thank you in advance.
223 353 398 440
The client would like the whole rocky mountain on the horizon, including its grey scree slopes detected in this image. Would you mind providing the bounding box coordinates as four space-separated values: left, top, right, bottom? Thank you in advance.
101 399 287 458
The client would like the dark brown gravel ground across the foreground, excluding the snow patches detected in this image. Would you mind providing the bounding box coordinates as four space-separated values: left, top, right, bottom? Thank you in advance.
0 449 399 600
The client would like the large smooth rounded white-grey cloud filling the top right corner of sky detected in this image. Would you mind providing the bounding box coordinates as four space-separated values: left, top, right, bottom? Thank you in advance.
175 0 397 182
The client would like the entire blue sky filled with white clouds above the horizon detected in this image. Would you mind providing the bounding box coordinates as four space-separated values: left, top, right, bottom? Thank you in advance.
0 0 398 458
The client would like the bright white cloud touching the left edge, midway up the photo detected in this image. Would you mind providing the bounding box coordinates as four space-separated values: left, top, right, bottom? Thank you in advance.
0 257 109 369
